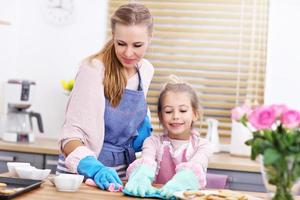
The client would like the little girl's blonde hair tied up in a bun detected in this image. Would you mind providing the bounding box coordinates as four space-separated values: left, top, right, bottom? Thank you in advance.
157 75 202 118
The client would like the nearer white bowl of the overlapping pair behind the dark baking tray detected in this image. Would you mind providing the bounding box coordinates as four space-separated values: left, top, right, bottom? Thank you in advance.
15 166 51 180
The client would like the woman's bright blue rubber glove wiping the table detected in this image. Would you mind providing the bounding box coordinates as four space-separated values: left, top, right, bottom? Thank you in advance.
77 156 123 190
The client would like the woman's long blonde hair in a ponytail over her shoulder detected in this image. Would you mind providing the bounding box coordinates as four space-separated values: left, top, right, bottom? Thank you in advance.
89 3 153 107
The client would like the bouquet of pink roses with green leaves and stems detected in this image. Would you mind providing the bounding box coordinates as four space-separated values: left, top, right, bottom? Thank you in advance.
232 105 300 200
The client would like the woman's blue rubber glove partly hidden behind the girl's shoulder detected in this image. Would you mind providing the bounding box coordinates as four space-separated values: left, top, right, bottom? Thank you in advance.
132 115 153 152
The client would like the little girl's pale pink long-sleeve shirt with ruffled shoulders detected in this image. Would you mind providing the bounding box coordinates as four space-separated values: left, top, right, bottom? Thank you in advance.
127 130 213 188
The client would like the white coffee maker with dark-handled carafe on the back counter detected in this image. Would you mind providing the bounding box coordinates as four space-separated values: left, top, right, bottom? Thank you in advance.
2 79 44 143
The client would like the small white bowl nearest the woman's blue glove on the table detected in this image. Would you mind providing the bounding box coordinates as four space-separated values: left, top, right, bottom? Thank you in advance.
54 174 83 192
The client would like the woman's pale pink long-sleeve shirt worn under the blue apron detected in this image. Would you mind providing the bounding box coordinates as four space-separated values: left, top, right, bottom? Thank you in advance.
59 59 154 173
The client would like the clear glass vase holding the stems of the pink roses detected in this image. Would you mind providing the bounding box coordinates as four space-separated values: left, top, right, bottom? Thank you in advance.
260 156 300 200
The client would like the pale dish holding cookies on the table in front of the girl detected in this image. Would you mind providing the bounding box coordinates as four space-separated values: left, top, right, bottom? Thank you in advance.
174 190 262 200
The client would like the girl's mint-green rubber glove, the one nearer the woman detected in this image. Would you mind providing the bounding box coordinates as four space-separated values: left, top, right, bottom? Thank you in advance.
123 165 159 197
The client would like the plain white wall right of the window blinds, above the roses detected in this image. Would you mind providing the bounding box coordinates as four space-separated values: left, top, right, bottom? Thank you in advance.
265 0 300 109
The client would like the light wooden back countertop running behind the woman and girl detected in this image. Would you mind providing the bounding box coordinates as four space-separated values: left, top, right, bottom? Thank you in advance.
0 138 260 172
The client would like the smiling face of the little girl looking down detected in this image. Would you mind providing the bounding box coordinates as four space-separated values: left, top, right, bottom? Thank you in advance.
159 91 198 140
